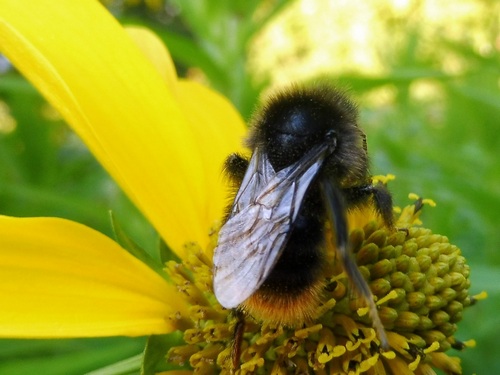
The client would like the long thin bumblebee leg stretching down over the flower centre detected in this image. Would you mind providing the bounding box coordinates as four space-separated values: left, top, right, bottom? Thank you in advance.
321 181 389 349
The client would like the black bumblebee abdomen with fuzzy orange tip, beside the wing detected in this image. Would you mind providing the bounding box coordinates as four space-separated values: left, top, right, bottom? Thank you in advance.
241 194 325 326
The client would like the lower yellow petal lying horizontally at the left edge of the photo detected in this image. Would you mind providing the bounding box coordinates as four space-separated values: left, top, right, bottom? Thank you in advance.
0 216 185 338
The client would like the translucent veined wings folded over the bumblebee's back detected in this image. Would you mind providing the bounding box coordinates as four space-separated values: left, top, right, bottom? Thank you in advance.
214 145 329 308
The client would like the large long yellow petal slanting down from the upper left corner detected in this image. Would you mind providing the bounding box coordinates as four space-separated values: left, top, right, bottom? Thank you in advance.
0 0 243 256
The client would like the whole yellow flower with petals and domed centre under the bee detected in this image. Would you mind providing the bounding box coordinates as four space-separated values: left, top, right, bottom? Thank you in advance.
0 0 474 374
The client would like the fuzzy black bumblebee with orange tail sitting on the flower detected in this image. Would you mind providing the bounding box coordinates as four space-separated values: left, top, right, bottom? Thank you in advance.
213 85 393 354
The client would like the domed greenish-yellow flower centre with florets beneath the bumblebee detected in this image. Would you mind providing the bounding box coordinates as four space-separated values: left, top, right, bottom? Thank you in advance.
166 195 476 375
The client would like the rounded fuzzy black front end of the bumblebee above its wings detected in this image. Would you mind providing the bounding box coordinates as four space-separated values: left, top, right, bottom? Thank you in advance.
248 86 366 177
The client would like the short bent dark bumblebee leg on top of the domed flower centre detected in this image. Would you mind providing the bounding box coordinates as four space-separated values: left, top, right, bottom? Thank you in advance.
342 182 394 229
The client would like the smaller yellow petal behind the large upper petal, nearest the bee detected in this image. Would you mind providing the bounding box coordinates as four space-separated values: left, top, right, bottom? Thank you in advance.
126 27 246 234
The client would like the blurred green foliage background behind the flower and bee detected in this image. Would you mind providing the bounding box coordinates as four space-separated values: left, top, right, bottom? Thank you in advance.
0 0 500 374
